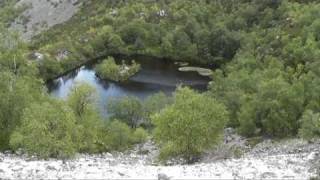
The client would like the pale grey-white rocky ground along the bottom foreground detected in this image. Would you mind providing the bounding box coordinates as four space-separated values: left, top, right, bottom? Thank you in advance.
0 139 320 179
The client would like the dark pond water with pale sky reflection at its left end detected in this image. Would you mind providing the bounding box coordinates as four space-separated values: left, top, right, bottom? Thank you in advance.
47 57 210 116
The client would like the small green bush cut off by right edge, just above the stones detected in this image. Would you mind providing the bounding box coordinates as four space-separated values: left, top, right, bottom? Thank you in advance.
299 110 320 140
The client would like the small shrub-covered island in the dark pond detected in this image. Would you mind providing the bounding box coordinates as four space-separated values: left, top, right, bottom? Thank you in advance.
96 57 141 82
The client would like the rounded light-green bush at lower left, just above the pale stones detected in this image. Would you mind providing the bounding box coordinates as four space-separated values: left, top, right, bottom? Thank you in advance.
10 100 77 158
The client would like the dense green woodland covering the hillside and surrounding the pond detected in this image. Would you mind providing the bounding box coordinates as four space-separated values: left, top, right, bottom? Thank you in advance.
0 0 320 162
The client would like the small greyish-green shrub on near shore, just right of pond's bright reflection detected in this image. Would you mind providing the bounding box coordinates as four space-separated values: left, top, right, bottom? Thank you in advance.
107 96 143 128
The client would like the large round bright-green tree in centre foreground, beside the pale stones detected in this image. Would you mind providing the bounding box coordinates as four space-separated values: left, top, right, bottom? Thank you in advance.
152 87 228 163
